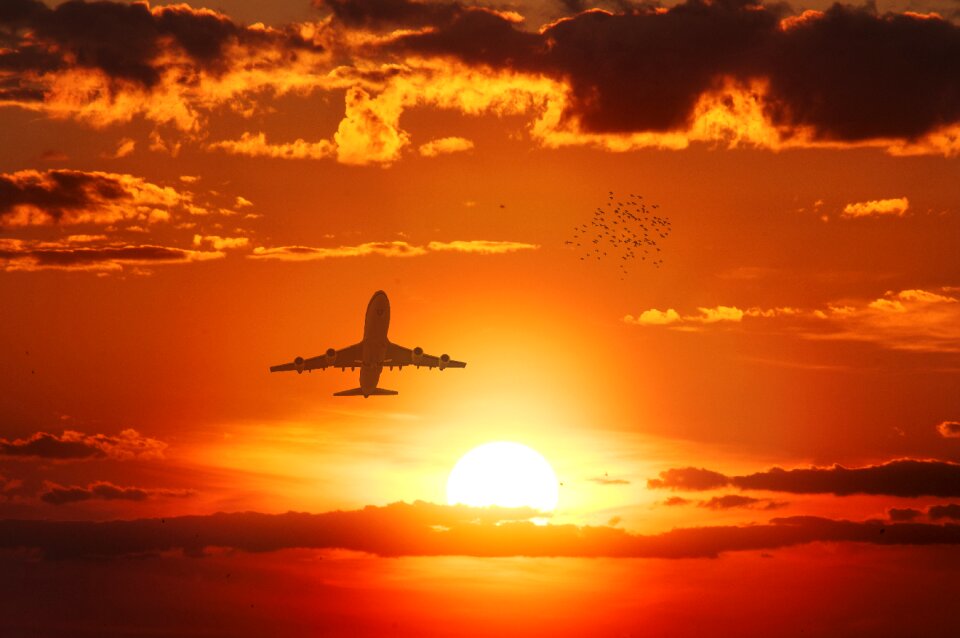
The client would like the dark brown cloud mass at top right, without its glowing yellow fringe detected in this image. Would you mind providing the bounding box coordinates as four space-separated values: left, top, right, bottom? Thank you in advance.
376 0 960 142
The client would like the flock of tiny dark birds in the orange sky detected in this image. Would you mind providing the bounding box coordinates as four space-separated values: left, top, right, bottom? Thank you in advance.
564 191 672 279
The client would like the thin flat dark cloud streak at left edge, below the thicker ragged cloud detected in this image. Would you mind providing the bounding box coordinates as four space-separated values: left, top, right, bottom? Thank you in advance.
0 239 225 273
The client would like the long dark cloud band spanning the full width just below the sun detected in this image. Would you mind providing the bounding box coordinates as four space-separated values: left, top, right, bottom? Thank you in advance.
0 502 960 558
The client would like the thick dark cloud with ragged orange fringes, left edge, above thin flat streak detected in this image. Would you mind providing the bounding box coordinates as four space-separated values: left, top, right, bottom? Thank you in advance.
0 169 192 227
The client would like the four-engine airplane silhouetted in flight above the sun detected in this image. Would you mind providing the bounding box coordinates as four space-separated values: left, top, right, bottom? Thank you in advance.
270 290 467 399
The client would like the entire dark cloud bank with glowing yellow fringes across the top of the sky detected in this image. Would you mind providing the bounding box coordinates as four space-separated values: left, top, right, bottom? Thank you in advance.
0 0 960 159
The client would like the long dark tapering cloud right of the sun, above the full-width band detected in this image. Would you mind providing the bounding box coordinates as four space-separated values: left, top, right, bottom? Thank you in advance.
647 459 960 497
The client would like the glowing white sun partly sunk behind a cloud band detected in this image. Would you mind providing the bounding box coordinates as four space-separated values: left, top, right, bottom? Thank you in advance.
447 441 560 512
